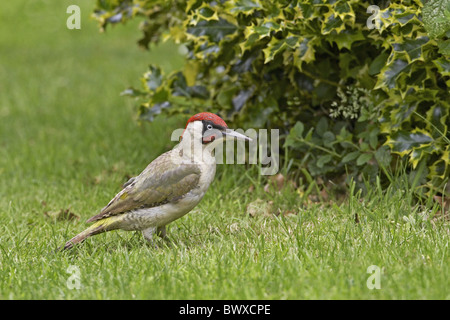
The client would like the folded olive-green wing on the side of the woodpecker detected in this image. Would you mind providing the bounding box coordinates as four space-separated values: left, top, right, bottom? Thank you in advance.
87 151 201 222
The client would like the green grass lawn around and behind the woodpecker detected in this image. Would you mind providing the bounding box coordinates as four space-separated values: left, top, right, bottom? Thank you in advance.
0 1 450 299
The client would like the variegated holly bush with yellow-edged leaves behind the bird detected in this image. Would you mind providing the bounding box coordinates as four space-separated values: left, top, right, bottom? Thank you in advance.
93 0 450 195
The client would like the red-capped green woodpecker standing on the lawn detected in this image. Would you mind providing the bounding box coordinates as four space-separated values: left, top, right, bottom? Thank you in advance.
62 112 251 250
